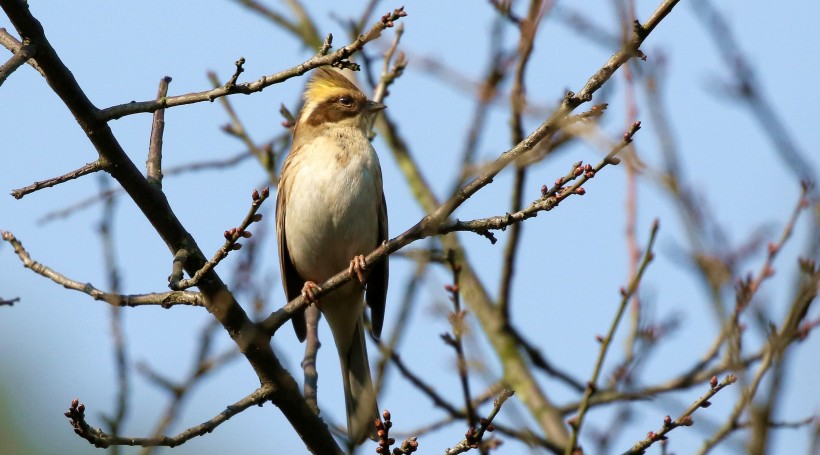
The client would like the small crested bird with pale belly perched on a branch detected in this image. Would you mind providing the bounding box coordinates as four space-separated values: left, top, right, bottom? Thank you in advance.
276 67 388 444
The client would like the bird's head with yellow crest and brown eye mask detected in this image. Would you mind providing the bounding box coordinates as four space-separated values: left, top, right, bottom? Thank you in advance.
297 67 385 132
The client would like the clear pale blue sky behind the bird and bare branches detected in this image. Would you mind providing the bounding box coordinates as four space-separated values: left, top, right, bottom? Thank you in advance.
0 0 820 454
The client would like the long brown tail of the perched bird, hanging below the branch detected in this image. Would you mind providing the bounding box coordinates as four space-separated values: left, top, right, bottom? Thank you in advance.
339 318 379 444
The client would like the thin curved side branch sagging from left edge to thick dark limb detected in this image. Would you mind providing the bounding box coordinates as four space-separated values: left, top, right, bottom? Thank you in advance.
1 231 205 308
